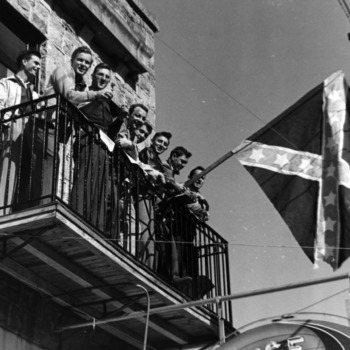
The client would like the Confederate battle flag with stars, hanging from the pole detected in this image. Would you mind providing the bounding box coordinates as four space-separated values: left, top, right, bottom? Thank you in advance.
234 71 350 270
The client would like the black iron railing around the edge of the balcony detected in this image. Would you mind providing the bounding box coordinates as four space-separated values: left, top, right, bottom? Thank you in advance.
0 95 232 322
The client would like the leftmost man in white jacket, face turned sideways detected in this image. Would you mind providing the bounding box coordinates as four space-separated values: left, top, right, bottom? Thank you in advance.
0 50 41 215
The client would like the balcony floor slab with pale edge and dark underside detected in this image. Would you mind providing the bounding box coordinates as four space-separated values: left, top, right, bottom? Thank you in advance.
0 203 234 349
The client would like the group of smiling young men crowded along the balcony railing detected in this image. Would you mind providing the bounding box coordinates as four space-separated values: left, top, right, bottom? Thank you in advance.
0 46 209 296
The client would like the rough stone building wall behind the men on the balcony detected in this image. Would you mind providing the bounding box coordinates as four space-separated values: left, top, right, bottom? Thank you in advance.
5 0 157 124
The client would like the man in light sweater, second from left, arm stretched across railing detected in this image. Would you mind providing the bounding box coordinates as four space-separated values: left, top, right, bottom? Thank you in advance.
19 46 113 206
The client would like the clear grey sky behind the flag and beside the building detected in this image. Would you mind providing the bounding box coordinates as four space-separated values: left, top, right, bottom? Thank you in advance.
142 0 350 328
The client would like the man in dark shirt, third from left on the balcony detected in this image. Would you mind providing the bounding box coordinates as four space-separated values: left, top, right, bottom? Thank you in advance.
70 63 124 235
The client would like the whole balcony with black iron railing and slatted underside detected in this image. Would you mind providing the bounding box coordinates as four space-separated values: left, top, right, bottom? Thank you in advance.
0 95 233 349
